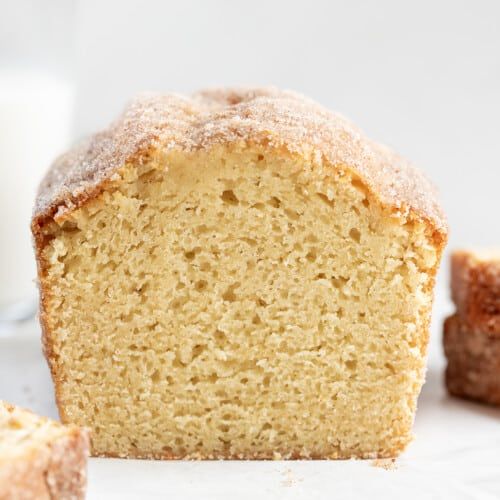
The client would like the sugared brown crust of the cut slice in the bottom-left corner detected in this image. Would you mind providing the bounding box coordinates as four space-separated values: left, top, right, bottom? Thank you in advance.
0 403 89 500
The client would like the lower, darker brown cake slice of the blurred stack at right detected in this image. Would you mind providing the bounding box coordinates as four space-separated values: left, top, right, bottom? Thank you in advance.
443 314 500 405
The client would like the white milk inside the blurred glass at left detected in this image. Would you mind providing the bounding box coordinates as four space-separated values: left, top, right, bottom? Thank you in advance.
0 70 74 304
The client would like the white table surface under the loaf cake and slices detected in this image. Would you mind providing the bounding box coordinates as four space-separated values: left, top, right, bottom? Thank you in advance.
0 293 500 500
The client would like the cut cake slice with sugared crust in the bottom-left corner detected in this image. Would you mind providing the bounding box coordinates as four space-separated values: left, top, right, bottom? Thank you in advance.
0 401 89 500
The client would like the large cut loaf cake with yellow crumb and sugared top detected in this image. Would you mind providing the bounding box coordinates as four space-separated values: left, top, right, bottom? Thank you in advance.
32 89 447 459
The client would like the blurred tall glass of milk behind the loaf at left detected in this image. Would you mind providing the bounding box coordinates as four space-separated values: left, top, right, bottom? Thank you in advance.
0 0 75 334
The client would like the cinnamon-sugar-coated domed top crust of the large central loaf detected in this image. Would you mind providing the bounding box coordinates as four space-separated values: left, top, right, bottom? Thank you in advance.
34 88 447 240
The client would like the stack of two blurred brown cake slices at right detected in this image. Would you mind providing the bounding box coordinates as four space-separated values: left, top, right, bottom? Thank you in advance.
443 250 500 405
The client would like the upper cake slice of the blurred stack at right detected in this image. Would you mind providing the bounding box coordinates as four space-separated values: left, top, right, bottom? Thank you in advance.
451 249 500 334
